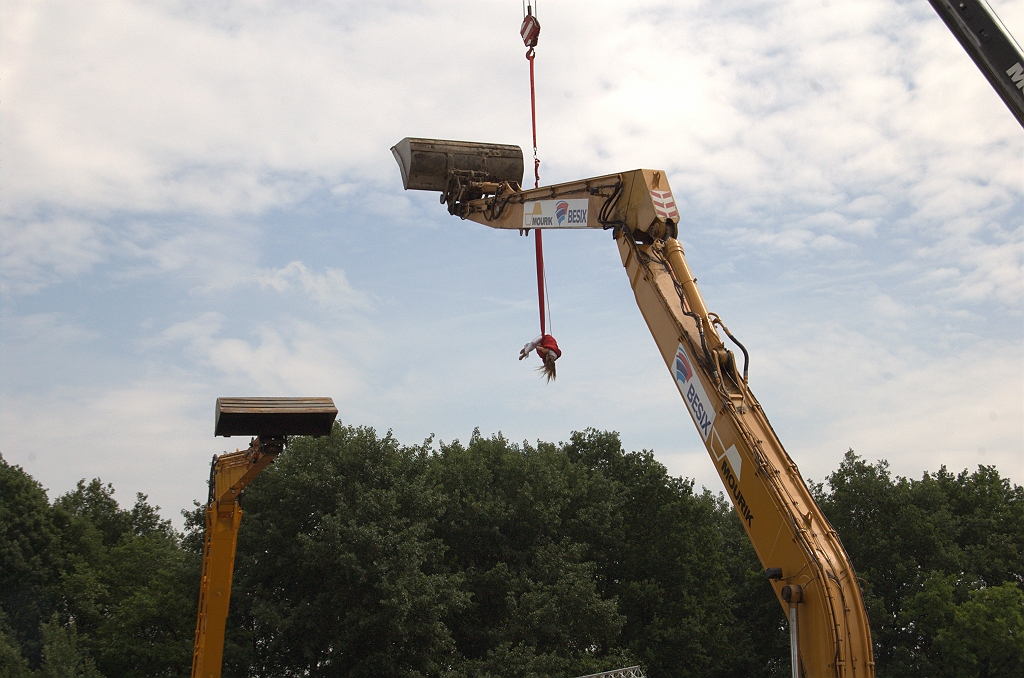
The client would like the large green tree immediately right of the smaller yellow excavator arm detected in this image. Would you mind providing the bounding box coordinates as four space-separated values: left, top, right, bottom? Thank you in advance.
225 426 466 676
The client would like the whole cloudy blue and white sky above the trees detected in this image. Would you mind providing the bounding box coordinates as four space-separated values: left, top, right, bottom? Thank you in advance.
6 0 1024 524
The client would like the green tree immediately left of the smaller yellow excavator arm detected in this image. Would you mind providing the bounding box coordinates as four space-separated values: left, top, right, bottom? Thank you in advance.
53 478 200 678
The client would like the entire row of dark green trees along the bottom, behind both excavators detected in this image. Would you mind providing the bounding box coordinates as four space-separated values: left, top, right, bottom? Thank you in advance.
0 425 1024 678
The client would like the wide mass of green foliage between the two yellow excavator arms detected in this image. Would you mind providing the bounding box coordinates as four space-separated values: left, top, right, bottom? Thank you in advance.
220 427 785 678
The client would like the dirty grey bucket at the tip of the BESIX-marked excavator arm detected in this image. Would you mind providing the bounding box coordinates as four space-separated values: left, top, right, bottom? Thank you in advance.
391 136 523 193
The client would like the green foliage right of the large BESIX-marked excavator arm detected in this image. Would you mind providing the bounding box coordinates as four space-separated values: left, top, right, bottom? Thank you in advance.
818 451 1024 678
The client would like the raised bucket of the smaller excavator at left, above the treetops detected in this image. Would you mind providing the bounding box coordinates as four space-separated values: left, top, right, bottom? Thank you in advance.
214 397 338 436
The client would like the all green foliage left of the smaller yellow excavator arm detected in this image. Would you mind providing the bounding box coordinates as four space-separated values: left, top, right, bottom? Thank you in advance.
0 458 199 678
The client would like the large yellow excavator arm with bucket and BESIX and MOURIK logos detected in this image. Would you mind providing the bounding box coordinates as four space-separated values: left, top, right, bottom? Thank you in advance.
391 138 874 678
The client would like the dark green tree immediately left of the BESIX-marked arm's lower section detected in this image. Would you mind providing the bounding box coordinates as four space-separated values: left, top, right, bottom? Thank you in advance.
564 429 785 678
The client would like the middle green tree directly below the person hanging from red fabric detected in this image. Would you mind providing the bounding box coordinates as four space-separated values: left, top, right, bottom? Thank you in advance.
427 430 631 676
